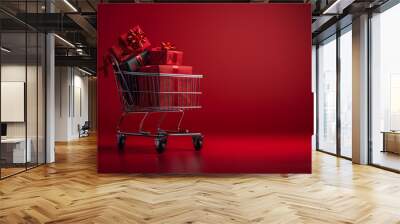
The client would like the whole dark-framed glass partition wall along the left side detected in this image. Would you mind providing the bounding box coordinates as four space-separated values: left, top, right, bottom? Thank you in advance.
0 1 46 179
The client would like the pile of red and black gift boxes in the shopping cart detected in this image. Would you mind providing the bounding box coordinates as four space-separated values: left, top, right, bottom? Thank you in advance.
110 26 192 107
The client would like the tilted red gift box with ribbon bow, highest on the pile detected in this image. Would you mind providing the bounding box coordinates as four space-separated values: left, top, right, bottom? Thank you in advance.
119 26 151 55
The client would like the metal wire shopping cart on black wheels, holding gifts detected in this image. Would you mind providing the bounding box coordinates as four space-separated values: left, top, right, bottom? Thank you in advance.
111 56 204 153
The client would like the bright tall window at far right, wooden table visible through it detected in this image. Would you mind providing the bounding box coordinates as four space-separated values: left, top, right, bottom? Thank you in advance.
370 4 400 171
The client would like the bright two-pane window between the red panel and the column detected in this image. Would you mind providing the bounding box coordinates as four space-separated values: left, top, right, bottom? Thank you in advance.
316 25 352 159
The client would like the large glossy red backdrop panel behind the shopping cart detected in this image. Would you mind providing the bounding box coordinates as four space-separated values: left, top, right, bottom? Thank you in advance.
97 4 313 173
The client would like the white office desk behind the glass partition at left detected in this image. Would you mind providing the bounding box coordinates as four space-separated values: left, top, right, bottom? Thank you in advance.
1 138 32 163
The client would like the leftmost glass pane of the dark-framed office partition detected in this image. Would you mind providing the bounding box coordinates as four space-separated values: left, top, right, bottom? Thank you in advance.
0 31 27 177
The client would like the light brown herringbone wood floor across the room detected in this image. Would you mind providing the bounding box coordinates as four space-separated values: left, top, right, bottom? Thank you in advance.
0 138 400 224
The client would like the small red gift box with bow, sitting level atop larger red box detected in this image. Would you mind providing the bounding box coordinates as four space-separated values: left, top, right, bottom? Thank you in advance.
148 42 183 65
